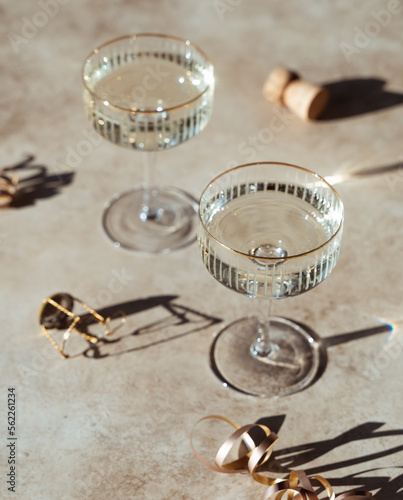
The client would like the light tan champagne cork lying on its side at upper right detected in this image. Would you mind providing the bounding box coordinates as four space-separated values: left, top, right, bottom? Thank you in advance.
263 68 329 120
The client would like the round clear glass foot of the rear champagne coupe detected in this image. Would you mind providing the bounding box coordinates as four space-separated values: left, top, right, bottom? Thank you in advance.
102 187 198 254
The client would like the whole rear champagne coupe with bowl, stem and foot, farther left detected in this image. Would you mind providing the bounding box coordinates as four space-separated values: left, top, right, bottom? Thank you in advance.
82 34 214 253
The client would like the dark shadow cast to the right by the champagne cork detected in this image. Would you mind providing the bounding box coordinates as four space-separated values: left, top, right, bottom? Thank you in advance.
318 78 403 121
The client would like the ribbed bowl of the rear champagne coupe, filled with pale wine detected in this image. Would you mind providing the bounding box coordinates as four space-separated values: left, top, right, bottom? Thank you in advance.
83 34 214 151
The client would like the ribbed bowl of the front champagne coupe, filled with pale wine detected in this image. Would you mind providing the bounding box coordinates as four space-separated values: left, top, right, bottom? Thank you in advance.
198 163 343 298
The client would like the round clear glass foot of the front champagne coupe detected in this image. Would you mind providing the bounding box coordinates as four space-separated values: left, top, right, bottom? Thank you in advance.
211 317 320 398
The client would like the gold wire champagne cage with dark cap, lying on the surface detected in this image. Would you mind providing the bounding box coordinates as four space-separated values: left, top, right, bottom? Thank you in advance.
39 292 126 359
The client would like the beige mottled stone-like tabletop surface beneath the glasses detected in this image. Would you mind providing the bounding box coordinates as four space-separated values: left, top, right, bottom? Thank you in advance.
0 0 403 500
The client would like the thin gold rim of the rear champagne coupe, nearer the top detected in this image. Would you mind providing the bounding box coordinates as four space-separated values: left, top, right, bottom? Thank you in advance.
81 33 213 115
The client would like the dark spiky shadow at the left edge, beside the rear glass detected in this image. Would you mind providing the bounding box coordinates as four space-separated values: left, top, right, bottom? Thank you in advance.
1 155 74 208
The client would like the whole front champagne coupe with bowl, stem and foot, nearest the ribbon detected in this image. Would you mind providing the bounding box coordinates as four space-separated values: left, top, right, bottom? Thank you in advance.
198 162 343 397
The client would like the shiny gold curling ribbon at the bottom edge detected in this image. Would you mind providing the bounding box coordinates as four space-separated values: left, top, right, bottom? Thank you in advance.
190 415 373 500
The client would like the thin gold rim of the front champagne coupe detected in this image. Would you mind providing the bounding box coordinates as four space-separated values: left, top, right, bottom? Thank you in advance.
199 161 343 262
